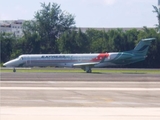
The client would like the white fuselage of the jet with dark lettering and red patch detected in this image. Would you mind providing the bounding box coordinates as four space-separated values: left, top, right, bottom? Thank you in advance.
4 53 119 67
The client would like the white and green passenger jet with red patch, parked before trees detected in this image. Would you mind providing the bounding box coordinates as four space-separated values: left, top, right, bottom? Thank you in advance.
3 38 155 73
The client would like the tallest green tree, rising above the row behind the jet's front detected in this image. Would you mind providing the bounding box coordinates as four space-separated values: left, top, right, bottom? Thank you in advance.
24 3 75 53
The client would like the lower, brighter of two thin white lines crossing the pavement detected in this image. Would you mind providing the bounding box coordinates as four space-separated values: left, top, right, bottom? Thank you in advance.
0 87 160 91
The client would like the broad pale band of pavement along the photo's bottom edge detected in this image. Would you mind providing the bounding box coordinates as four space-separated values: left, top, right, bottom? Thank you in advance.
1 107 160 120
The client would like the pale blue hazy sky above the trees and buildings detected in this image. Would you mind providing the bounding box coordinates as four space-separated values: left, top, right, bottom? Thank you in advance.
0 0 158 28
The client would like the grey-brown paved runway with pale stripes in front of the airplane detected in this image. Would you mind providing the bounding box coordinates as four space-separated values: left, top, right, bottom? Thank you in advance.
0 73 160 120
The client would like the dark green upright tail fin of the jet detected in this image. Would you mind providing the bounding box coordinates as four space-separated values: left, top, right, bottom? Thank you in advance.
133 38 155 56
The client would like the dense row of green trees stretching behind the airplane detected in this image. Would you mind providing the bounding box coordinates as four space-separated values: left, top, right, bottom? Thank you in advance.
0 3 160 68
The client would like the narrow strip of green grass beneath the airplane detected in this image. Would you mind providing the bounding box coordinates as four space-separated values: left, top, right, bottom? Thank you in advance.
0 68 160 74
